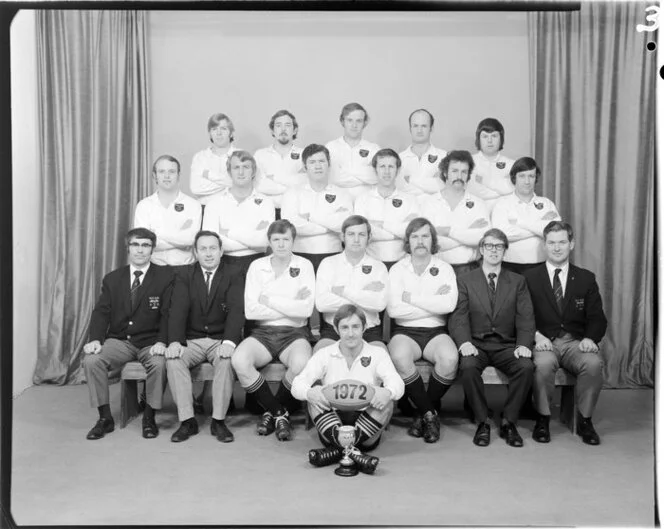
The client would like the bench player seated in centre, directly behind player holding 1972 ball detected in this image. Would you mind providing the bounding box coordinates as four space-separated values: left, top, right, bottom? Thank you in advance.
314 215 388 351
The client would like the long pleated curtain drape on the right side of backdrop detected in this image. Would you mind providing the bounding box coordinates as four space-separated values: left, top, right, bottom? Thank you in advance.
528 2 657 387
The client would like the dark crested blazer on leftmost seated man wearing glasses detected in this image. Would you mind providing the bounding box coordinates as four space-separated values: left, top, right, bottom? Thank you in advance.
90 263 174 348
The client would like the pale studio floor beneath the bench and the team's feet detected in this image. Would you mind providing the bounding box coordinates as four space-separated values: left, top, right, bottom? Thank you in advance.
11 384 655 527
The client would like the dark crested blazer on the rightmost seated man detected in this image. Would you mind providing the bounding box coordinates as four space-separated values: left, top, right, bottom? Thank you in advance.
524 263 607 343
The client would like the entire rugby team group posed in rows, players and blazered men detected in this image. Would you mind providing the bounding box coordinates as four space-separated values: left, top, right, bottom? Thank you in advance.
83 103 607 467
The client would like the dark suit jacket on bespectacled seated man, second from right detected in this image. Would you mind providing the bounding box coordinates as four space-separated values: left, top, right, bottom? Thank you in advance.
448 267 535 349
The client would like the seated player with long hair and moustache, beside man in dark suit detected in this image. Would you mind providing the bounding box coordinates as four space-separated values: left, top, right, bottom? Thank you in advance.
387 217 459 443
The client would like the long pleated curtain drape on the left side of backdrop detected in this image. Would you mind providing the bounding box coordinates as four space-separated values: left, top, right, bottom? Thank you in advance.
34 10 149 384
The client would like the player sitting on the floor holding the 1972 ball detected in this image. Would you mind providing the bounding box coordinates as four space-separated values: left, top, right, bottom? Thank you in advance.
292 304 403 473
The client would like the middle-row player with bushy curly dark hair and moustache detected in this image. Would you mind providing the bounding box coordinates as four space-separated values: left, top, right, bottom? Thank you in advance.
422 151 490 276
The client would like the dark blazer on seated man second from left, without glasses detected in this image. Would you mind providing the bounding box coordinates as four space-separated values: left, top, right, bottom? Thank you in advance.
168 263 244 345
